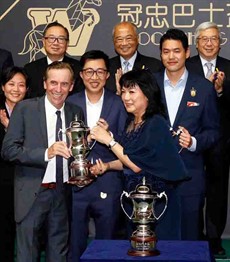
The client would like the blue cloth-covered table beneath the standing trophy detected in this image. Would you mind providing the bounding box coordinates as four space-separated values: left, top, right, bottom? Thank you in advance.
81 240 214 262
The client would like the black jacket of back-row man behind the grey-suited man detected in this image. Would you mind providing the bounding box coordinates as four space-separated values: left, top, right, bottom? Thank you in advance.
24 56 82 98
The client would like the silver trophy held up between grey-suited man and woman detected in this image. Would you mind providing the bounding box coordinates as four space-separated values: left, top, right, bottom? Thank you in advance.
60 116 96 187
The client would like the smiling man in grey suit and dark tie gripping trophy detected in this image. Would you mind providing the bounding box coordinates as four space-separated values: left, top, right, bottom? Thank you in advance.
2 62 83 262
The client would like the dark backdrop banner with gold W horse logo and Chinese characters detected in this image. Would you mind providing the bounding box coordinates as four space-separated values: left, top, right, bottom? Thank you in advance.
0 0 230 65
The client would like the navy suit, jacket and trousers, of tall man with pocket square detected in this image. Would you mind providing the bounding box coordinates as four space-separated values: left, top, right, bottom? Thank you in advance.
155 72 219 240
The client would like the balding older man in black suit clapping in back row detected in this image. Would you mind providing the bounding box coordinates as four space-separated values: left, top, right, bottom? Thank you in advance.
106 22 162 94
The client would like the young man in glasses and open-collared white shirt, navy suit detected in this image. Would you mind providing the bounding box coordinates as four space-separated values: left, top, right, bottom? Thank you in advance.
68 50 127 262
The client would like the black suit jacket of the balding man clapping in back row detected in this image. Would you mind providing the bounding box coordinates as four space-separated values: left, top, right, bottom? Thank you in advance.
106 52 163 93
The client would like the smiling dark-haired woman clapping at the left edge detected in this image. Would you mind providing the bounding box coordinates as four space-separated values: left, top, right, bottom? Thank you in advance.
0 67 27 262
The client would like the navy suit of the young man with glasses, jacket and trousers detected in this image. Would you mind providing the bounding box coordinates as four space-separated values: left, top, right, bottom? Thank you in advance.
68 89 127 262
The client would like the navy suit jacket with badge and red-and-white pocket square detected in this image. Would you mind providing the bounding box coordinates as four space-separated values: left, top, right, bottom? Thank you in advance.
155 72 219 195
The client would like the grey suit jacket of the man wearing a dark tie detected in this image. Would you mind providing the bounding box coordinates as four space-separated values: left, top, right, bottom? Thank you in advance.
2 97 83 222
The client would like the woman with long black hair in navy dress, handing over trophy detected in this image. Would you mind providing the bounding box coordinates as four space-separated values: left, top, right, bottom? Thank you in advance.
91 70 188 239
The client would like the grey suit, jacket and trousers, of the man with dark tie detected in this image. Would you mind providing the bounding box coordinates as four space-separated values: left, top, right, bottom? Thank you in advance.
2 97 83 262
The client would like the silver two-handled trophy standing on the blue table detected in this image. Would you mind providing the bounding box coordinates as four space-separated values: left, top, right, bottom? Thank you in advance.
120 178 168 256
